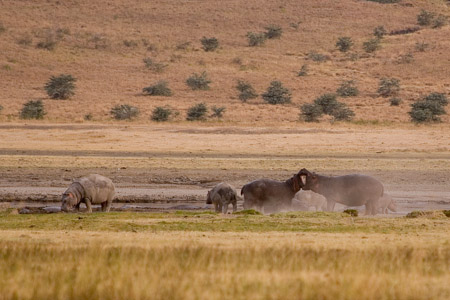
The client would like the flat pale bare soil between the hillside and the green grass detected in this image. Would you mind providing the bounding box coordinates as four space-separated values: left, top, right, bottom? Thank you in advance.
0 124 450 214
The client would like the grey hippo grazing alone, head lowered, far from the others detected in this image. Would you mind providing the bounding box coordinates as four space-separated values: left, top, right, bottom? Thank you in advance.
61 174 115 213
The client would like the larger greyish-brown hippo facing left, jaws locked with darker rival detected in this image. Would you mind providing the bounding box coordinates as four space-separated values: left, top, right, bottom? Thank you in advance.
299 169 384 215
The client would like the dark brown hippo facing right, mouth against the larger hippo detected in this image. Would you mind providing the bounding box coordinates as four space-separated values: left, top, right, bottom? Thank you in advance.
241 174 302 213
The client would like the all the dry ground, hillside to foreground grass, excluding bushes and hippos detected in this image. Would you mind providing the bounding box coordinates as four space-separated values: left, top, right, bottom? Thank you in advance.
0 0 450 300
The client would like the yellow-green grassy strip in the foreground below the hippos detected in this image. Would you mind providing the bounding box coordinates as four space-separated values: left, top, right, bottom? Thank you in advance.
0 212 450 299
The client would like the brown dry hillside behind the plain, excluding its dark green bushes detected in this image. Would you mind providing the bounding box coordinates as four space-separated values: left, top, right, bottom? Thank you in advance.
0 0 450 125
